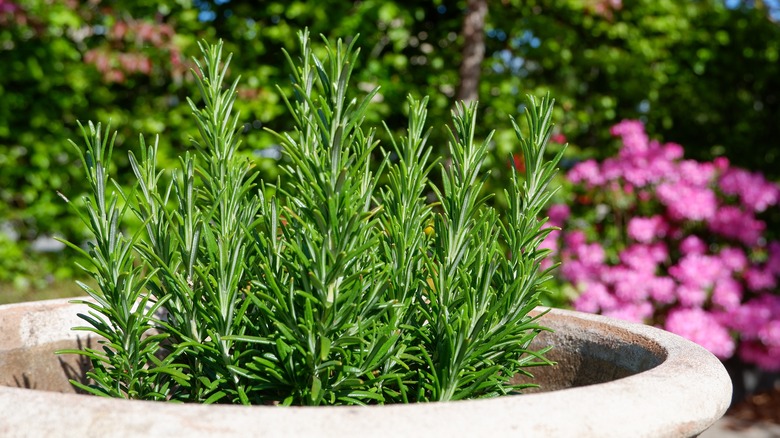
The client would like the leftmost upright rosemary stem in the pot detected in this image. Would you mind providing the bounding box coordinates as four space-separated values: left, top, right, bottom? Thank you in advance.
55 123 176 400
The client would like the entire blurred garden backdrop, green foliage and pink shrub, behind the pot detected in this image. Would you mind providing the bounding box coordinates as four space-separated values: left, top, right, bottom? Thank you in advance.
0 0 780 414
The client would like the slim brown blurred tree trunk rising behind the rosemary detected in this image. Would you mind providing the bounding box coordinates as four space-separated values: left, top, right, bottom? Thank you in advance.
457 0 487 102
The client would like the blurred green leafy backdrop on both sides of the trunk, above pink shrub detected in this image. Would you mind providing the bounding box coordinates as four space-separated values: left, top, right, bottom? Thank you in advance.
0 0 780 301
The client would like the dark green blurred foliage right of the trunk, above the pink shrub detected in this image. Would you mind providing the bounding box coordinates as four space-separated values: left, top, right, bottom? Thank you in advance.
482 0 780 179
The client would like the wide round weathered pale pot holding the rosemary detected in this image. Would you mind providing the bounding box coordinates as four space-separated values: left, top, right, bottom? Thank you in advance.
0 300 731 437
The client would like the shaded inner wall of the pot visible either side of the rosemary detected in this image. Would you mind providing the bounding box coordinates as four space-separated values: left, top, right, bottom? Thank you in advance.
0 303 666 393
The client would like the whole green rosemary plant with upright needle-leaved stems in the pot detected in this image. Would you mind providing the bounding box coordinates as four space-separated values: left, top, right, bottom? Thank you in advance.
61 32 560 405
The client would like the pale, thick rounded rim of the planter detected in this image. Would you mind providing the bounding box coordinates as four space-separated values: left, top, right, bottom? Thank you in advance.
0 299 731 437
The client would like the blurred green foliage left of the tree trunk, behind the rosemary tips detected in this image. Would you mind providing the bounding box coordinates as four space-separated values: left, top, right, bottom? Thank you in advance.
0 0 472 290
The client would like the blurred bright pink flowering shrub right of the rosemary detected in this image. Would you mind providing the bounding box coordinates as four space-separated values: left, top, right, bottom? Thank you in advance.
544 120 780 370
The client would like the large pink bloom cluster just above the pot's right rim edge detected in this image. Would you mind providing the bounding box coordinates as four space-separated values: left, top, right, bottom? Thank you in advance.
664 308 735 359
